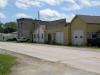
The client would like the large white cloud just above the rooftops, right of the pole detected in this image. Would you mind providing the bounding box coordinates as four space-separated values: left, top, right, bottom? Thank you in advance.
40 9 74 21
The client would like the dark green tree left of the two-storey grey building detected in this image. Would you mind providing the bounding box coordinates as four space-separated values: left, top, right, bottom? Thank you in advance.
4 22 17 33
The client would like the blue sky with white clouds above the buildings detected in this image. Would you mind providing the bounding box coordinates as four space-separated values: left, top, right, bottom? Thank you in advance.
0 0 100 23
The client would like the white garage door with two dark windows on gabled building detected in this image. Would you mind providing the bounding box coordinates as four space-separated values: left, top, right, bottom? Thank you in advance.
72 30 83 45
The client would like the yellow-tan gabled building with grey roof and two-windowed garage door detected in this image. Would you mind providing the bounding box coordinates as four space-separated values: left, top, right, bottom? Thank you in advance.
65 15 100 45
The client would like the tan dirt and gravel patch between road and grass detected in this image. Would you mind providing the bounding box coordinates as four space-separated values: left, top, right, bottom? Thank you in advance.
0 50 99 75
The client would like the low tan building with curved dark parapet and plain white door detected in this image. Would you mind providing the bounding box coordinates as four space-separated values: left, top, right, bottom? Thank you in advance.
46 19 66 44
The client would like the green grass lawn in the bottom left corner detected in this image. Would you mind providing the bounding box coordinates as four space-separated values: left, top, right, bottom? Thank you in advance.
0 54 16 75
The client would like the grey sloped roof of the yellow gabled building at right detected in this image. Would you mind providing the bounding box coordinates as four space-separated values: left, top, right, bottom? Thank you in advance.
77 15 100 24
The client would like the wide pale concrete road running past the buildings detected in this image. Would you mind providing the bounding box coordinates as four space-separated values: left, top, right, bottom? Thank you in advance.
0 42 100 74
